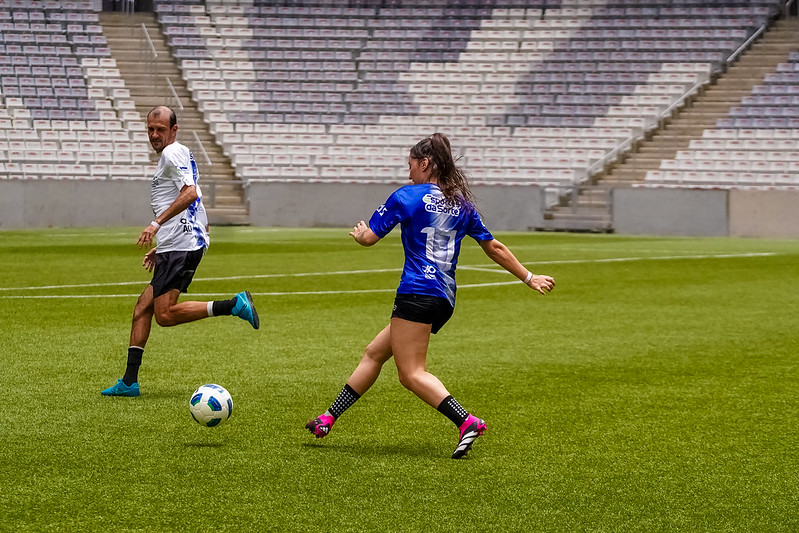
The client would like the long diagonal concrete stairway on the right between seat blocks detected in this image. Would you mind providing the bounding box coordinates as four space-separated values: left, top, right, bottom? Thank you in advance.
542 17 799 231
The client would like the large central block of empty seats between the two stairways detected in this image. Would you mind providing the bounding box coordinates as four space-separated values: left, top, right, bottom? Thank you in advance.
150 2 774 212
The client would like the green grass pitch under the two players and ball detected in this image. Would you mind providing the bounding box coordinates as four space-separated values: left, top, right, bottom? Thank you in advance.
0 228 799 532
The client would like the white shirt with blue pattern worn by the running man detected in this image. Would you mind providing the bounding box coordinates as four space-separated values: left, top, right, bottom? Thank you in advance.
152 142 209 253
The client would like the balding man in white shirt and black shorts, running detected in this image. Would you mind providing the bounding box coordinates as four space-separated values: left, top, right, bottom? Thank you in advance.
102 106 260 396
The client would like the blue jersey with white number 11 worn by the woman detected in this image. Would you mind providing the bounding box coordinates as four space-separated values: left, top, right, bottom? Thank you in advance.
369 183 494 306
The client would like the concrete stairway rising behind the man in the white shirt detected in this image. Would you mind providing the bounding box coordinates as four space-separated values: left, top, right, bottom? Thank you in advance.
100 12 249 225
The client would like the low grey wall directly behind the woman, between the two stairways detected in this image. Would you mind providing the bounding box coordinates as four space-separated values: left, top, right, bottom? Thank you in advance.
249 180 543 231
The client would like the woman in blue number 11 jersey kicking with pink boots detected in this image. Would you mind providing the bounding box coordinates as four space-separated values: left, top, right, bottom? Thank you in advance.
305 133 555 459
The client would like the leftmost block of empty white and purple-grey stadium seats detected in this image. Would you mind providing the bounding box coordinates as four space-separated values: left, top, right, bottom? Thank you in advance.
0 1 155 179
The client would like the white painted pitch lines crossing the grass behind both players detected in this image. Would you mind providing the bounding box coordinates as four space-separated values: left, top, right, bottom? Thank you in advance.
0 252 777 299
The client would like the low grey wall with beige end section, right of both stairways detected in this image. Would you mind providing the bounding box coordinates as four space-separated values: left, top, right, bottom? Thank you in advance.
613 187 799 238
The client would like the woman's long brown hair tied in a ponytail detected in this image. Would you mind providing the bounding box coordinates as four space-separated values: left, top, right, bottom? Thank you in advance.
410 133 474 207
